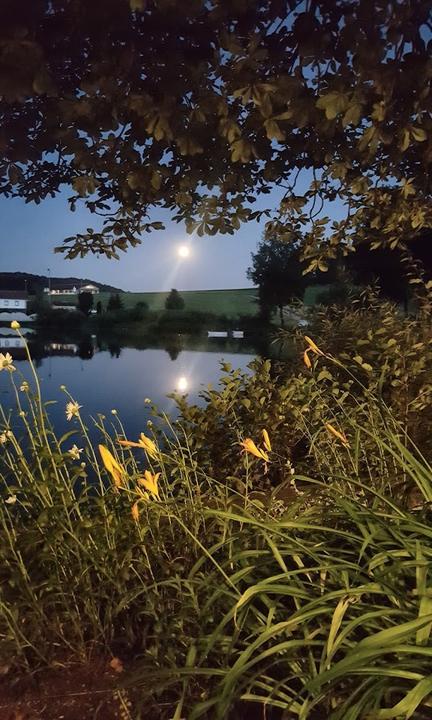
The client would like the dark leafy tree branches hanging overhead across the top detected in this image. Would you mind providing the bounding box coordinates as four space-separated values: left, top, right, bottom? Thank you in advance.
0 0 432 258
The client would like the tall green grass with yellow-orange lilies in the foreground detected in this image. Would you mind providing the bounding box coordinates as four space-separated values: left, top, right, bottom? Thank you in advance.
0 330 432 720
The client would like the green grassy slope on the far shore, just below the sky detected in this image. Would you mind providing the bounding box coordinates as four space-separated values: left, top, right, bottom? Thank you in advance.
53 288 258 316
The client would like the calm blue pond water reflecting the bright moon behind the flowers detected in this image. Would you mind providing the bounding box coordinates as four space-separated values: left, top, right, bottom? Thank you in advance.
0 335 282 438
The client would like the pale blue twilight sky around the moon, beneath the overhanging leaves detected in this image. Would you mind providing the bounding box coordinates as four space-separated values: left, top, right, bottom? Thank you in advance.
0 183 341 292
